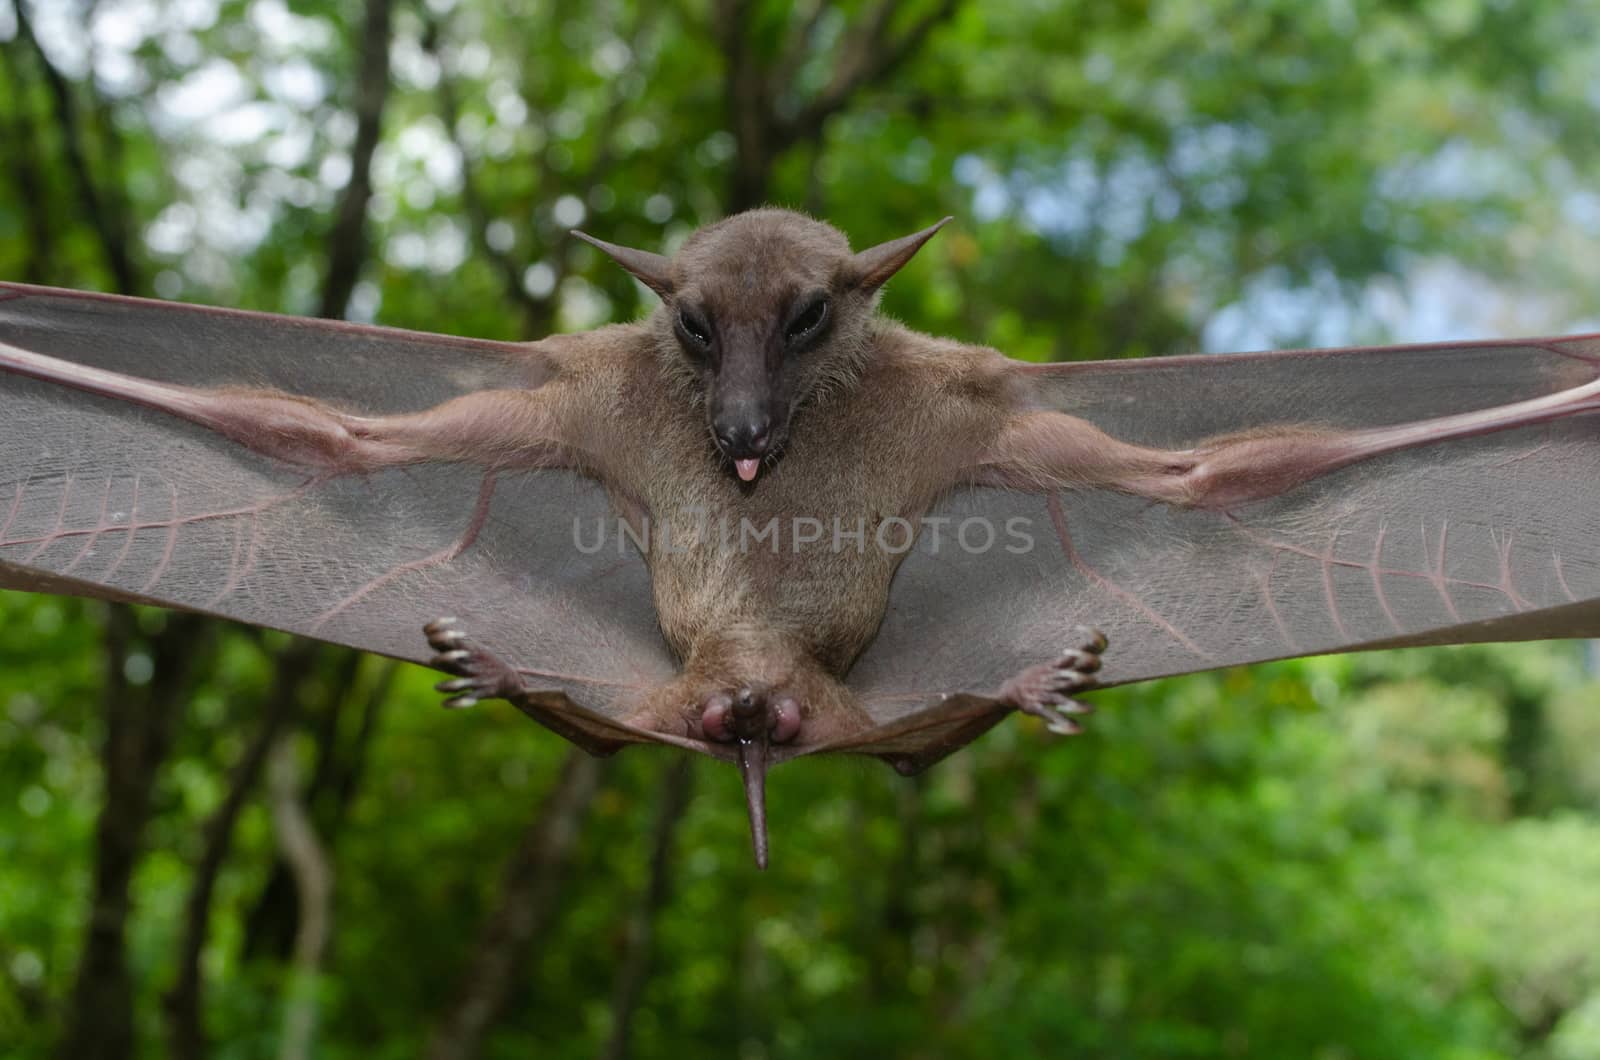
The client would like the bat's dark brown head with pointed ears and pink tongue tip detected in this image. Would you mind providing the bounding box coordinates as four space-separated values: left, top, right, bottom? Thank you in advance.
574 210 949 482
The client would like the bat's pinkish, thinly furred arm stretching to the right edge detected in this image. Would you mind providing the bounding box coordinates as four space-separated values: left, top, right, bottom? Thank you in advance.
978 381 1600 511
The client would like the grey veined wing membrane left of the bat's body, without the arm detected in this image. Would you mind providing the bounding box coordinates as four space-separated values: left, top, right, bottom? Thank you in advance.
0 283 674 738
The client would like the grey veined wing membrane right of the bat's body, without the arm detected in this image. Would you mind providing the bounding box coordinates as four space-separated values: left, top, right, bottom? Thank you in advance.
851 336 1600 753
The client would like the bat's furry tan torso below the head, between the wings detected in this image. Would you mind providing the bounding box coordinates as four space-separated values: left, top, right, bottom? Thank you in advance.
613 325 1000 717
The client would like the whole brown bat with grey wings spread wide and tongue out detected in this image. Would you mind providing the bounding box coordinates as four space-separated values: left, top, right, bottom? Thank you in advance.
0 210 1600 866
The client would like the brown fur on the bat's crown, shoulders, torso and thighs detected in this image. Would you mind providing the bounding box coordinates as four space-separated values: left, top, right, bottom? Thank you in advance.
537 210 1008 743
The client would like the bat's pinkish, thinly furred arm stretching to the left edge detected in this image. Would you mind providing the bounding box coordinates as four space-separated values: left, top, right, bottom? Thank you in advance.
0 343 578 474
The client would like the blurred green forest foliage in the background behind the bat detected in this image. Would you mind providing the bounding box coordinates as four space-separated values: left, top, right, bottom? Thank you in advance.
0 0 1600 1060
